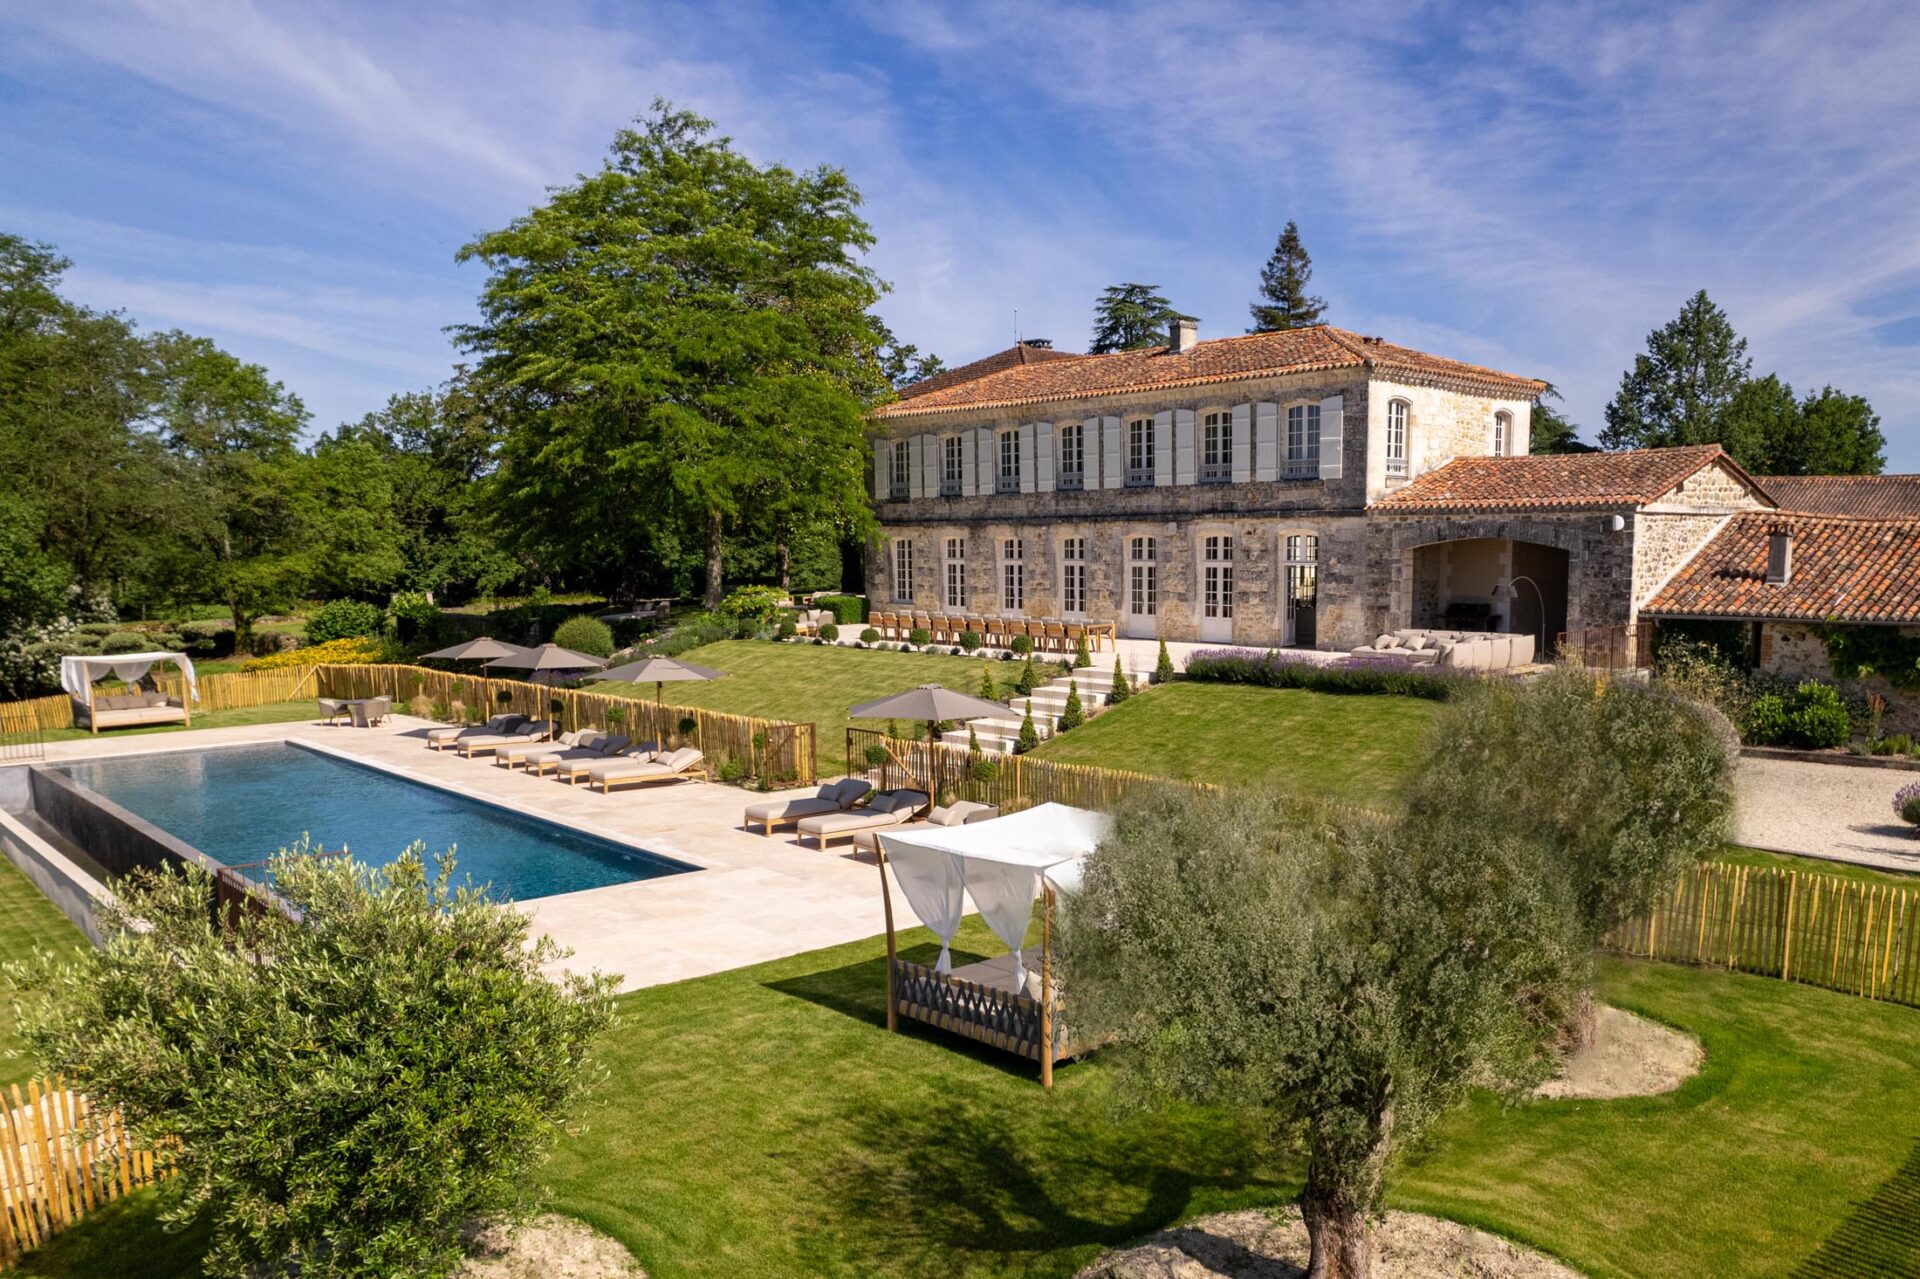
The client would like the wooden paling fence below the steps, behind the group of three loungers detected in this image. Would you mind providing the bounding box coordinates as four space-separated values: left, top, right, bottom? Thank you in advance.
847 728 1217 812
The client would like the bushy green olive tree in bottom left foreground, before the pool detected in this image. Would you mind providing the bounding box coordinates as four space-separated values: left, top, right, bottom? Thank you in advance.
13 845 612 1279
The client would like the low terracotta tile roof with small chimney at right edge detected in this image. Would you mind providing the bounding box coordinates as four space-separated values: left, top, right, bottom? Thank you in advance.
1642 511 1920 622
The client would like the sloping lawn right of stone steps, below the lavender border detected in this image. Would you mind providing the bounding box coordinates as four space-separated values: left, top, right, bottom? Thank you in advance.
1037 682 1438 805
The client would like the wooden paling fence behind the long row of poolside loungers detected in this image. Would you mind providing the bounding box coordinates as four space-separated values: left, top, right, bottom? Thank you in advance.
315 664 820 787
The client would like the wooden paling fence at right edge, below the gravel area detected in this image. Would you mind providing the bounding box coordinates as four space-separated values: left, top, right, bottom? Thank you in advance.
1607 862 1920 1006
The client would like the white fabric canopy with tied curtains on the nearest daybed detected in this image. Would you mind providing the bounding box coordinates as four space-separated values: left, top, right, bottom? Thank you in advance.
879 805 1114 989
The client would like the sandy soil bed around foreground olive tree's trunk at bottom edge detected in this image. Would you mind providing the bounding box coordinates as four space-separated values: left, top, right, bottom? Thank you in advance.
1079 1208 1580 1279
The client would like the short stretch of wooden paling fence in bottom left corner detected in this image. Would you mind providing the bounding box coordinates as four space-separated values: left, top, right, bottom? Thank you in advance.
0 1079 167 1267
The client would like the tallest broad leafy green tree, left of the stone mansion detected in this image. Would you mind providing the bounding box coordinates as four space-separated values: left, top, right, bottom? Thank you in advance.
459 104 883 603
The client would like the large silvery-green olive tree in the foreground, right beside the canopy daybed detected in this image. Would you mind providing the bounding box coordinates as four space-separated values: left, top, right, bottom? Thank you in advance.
1062 793 1586 1279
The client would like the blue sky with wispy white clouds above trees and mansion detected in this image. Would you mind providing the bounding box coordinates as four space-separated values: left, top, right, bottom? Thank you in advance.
0 0 1920 471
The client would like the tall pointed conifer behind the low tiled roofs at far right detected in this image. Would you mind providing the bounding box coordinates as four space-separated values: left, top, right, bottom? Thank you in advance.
1599 288 1753 449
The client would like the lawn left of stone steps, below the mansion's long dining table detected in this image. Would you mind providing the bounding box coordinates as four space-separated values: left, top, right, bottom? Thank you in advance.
591 640 1016 776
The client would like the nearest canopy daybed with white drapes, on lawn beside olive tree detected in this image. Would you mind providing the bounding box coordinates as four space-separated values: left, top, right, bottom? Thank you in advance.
879 805 1114 1087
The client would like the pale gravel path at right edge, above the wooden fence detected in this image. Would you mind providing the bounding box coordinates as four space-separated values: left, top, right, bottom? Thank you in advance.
1734 757 1920 872
